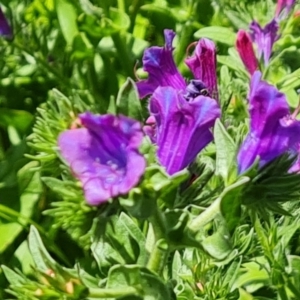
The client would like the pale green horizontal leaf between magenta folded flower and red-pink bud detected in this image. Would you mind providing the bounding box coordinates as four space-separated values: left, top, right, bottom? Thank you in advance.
194 26 236 46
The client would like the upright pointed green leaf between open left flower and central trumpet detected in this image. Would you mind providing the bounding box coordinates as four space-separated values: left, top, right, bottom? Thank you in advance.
117 78 143 121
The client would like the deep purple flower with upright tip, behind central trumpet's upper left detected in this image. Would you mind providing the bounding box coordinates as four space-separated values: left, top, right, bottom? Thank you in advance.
136 29 186 98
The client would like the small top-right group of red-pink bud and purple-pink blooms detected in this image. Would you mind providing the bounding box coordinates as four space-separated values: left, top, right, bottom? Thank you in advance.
236 0 295 75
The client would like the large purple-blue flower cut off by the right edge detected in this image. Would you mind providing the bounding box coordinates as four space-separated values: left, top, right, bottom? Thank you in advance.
237 71 300 173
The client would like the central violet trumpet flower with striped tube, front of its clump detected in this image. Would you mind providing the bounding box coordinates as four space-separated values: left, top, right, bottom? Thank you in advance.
149 86 220 175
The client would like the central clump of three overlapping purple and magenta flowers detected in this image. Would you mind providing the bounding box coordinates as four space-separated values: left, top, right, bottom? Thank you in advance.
137 30 220 175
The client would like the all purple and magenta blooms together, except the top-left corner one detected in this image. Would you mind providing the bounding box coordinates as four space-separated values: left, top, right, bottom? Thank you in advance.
42 1 300 205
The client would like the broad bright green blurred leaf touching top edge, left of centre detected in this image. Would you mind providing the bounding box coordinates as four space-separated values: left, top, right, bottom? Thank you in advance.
55 0 78 46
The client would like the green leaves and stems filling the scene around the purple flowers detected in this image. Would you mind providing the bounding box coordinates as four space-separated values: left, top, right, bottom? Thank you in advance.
0 0 300 300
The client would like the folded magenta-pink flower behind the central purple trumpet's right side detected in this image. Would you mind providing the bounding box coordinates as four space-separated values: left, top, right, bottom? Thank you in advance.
185 38 218 100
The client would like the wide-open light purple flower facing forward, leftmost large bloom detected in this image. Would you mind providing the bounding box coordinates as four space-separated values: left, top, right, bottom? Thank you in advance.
58 112 146 205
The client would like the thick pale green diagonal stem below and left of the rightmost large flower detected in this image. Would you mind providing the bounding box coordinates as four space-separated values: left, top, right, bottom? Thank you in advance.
188 197 222 233
